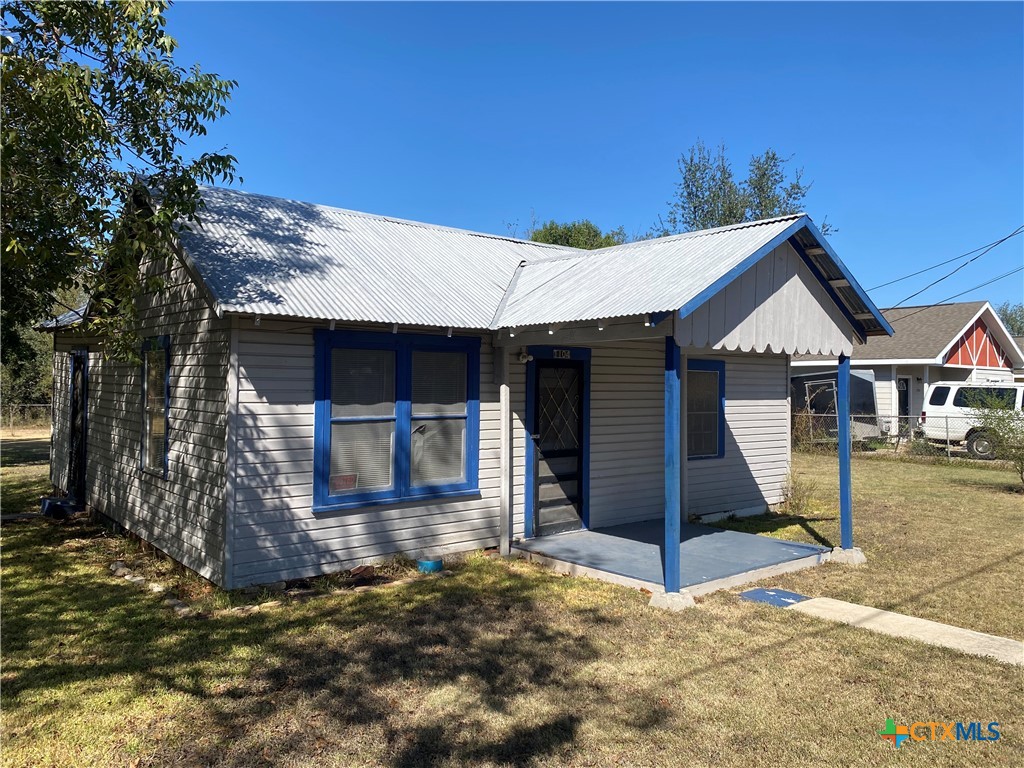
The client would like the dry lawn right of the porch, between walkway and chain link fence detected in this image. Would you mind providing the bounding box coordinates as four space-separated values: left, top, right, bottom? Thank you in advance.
719 454 1024 640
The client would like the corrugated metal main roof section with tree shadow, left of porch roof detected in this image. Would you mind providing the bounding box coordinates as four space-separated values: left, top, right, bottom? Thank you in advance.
181 187 575 329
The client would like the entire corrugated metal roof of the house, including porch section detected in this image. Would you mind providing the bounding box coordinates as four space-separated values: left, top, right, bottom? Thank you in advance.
172 187 892 336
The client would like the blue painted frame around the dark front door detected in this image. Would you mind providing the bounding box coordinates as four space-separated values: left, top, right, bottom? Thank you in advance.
523 346 591 539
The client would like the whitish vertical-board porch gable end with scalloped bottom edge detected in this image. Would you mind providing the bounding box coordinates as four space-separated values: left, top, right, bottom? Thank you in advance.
676 243 853 356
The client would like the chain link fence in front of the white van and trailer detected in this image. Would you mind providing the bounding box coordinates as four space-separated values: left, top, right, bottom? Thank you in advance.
793 413 998 460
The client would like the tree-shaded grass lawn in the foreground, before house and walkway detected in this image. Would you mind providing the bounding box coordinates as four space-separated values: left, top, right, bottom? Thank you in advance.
0 442 1024 767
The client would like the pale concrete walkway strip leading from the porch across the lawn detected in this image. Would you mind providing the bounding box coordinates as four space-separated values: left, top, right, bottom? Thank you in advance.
785 597 1024 667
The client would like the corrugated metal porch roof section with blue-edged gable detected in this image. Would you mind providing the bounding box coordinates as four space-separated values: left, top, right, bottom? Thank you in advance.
494 214 889 335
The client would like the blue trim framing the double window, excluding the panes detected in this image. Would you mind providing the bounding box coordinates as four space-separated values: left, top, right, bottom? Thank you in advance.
313 329 480 512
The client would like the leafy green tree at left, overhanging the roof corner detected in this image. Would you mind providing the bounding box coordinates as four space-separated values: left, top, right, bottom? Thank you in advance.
0 0 237 355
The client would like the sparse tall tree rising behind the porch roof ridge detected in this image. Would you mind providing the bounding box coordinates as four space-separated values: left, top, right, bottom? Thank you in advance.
650 139 834 238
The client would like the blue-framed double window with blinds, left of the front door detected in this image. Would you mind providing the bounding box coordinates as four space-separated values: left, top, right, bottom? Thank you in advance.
313 331 480 509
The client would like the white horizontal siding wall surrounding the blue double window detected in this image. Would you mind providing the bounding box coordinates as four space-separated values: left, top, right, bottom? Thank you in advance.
230 319 505 587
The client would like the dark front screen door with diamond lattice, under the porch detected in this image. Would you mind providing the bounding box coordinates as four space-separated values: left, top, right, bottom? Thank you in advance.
531 359 586 536
